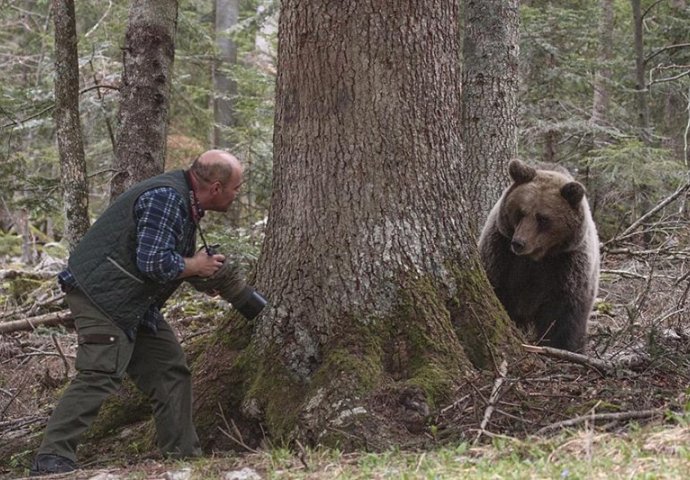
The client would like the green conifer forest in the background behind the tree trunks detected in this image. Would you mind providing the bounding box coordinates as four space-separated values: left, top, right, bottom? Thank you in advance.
0 1 690 248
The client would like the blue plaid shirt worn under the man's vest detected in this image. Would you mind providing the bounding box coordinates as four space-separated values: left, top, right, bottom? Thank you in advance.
58 187 198 331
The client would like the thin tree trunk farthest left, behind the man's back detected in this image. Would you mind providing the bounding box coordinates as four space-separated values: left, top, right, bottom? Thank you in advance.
53 0 89 250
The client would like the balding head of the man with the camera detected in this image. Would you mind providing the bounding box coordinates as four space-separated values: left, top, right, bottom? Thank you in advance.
190 150 243 212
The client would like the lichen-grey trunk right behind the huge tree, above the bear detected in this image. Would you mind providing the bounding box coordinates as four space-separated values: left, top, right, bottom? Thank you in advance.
461 0 520 230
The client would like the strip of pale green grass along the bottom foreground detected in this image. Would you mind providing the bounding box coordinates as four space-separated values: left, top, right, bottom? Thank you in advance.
10 424 690 480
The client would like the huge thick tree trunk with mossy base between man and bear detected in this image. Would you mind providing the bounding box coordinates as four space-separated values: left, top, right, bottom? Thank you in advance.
195 0 517 448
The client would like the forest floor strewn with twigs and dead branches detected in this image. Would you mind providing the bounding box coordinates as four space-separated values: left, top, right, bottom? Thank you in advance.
0 238 690 480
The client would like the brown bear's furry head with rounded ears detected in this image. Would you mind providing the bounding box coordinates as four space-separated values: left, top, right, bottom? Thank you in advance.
498 160 589 261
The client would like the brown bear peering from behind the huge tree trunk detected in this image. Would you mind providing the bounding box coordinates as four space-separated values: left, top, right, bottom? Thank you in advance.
479 160 599 352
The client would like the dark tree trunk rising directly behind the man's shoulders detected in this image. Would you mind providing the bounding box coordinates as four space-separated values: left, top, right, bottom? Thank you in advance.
110 0 177 202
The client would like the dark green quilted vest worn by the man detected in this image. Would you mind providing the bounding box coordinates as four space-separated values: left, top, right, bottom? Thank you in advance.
68 170 195 332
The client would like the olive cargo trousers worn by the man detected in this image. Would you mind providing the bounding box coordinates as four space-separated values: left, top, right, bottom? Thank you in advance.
38 290 201 461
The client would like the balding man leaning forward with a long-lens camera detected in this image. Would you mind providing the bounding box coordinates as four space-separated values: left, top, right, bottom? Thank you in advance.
30 150 265 475
